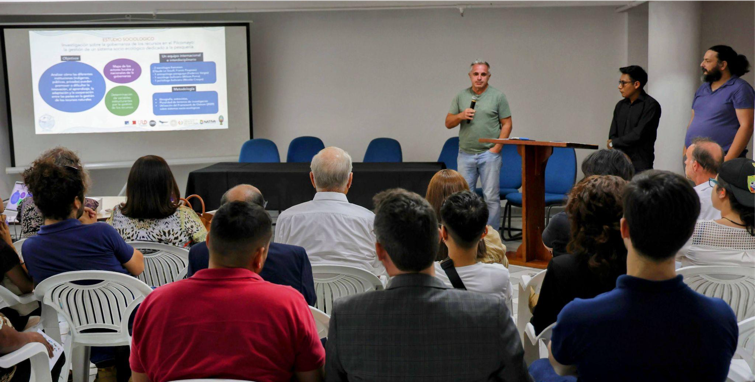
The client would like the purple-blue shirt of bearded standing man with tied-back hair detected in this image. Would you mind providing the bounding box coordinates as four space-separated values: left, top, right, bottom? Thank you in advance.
684 76 755 151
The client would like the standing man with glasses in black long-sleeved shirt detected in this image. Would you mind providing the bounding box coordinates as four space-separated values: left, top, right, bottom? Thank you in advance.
608 65 661 173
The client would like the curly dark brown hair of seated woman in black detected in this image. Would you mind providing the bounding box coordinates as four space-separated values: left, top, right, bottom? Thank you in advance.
566 175 627 283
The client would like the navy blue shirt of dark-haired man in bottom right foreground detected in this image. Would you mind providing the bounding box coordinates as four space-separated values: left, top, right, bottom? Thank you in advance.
551 275 739 382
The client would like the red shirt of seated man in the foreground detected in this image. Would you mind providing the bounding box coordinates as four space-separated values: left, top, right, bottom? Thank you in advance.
130 268 325 382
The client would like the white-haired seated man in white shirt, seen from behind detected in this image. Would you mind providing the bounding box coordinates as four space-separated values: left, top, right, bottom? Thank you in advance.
275 147 385 276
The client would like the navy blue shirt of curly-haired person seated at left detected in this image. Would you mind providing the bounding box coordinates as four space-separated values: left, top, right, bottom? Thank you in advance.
21 219 134 284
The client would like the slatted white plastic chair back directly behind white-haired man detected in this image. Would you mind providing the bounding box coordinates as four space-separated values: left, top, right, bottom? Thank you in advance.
312 265 383 314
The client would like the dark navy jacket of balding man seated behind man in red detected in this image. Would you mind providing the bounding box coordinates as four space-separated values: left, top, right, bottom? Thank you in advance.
186 242 317 306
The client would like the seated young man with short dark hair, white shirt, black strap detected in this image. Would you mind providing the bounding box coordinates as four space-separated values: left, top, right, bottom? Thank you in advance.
435 191 512 308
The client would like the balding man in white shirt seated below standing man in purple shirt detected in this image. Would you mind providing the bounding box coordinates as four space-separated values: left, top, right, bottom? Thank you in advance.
684 138 724 220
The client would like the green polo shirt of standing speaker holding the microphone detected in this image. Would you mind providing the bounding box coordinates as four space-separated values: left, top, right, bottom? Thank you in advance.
448 85 511 154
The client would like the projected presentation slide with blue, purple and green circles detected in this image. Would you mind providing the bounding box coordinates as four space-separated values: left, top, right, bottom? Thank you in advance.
28 27 231 135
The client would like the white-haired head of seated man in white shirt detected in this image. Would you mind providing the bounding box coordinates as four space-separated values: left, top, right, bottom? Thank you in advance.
310 147 351 190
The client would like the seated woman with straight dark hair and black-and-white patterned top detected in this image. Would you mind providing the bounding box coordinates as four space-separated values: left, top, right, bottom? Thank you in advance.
107 155 207 247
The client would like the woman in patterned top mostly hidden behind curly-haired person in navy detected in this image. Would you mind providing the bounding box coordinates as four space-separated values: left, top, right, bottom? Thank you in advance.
16 147 97 238
